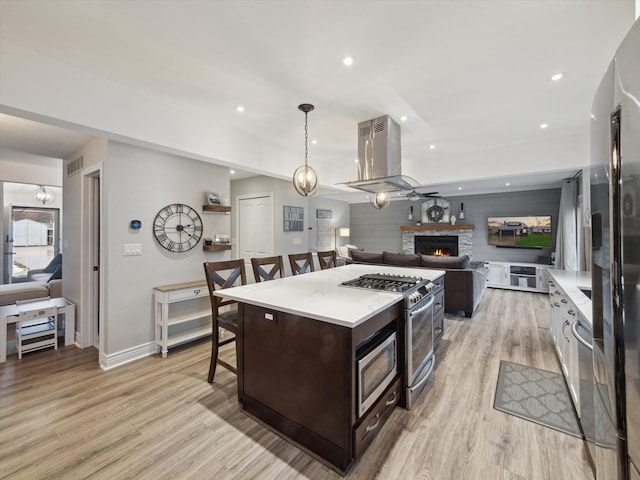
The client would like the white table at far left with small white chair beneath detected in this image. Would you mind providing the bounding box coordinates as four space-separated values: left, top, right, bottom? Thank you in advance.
0 298 76 363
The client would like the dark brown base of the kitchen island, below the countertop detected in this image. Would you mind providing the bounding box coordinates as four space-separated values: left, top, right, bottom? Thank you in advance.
237 302 404 474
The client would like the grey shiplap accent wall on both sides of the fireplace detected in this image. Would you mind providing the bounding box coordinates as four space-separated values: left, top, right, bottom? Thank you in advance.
351 188 560 263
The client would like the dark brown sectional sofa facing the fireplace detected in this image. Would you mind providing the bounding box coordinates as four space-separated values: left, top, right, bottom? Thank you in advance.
350 250 488 317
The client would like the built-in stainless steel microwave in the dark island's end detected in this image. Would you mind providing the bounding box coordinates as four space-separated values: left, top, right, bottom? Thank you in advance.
357 332 398 417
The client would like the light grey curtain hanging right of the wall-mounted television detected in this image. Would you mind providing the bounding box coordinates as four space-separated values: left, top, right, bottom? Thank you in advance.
554 179 582 271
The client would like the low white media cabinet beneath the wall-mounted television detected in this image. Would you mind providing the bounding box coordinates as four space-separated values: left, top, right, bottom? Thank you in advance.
486 262 549 293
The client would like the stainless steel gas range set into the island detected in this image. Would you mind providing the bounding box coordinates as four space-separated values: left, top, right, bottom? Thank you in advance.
341 273 436 409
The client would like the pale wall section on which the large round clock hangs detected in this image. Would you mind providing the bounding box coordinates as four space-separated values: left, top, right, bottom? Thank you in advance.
102 142 230 355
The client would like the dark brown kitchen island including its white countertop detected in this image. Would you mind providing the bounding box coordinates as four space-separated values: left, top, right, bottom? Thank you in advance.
217 265 444 473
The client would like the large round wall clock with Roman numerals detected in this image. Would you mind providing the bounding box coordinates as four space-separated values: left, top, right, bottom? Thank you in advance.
153 203 202 253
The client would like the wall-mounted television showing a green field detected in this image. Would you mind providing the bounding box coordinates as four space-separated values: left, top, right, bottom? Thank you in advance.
487 215 551 248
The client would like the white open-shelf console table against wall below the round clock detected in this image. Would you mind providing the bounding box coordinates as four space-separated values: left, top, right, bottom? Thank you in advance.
153 280 211 357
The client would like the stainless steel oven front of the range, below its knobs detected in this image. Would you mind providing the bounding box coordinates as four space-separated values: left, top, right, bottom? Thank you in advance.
405 295 434 409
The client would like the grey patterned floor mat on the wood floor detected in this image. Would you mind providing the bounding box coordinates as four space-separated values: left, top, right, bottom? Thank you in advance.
493 360 582 438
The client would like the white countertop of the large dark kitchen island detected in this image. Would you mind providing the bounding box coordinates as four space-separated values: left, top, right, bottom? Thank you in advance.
215 264 444 328
